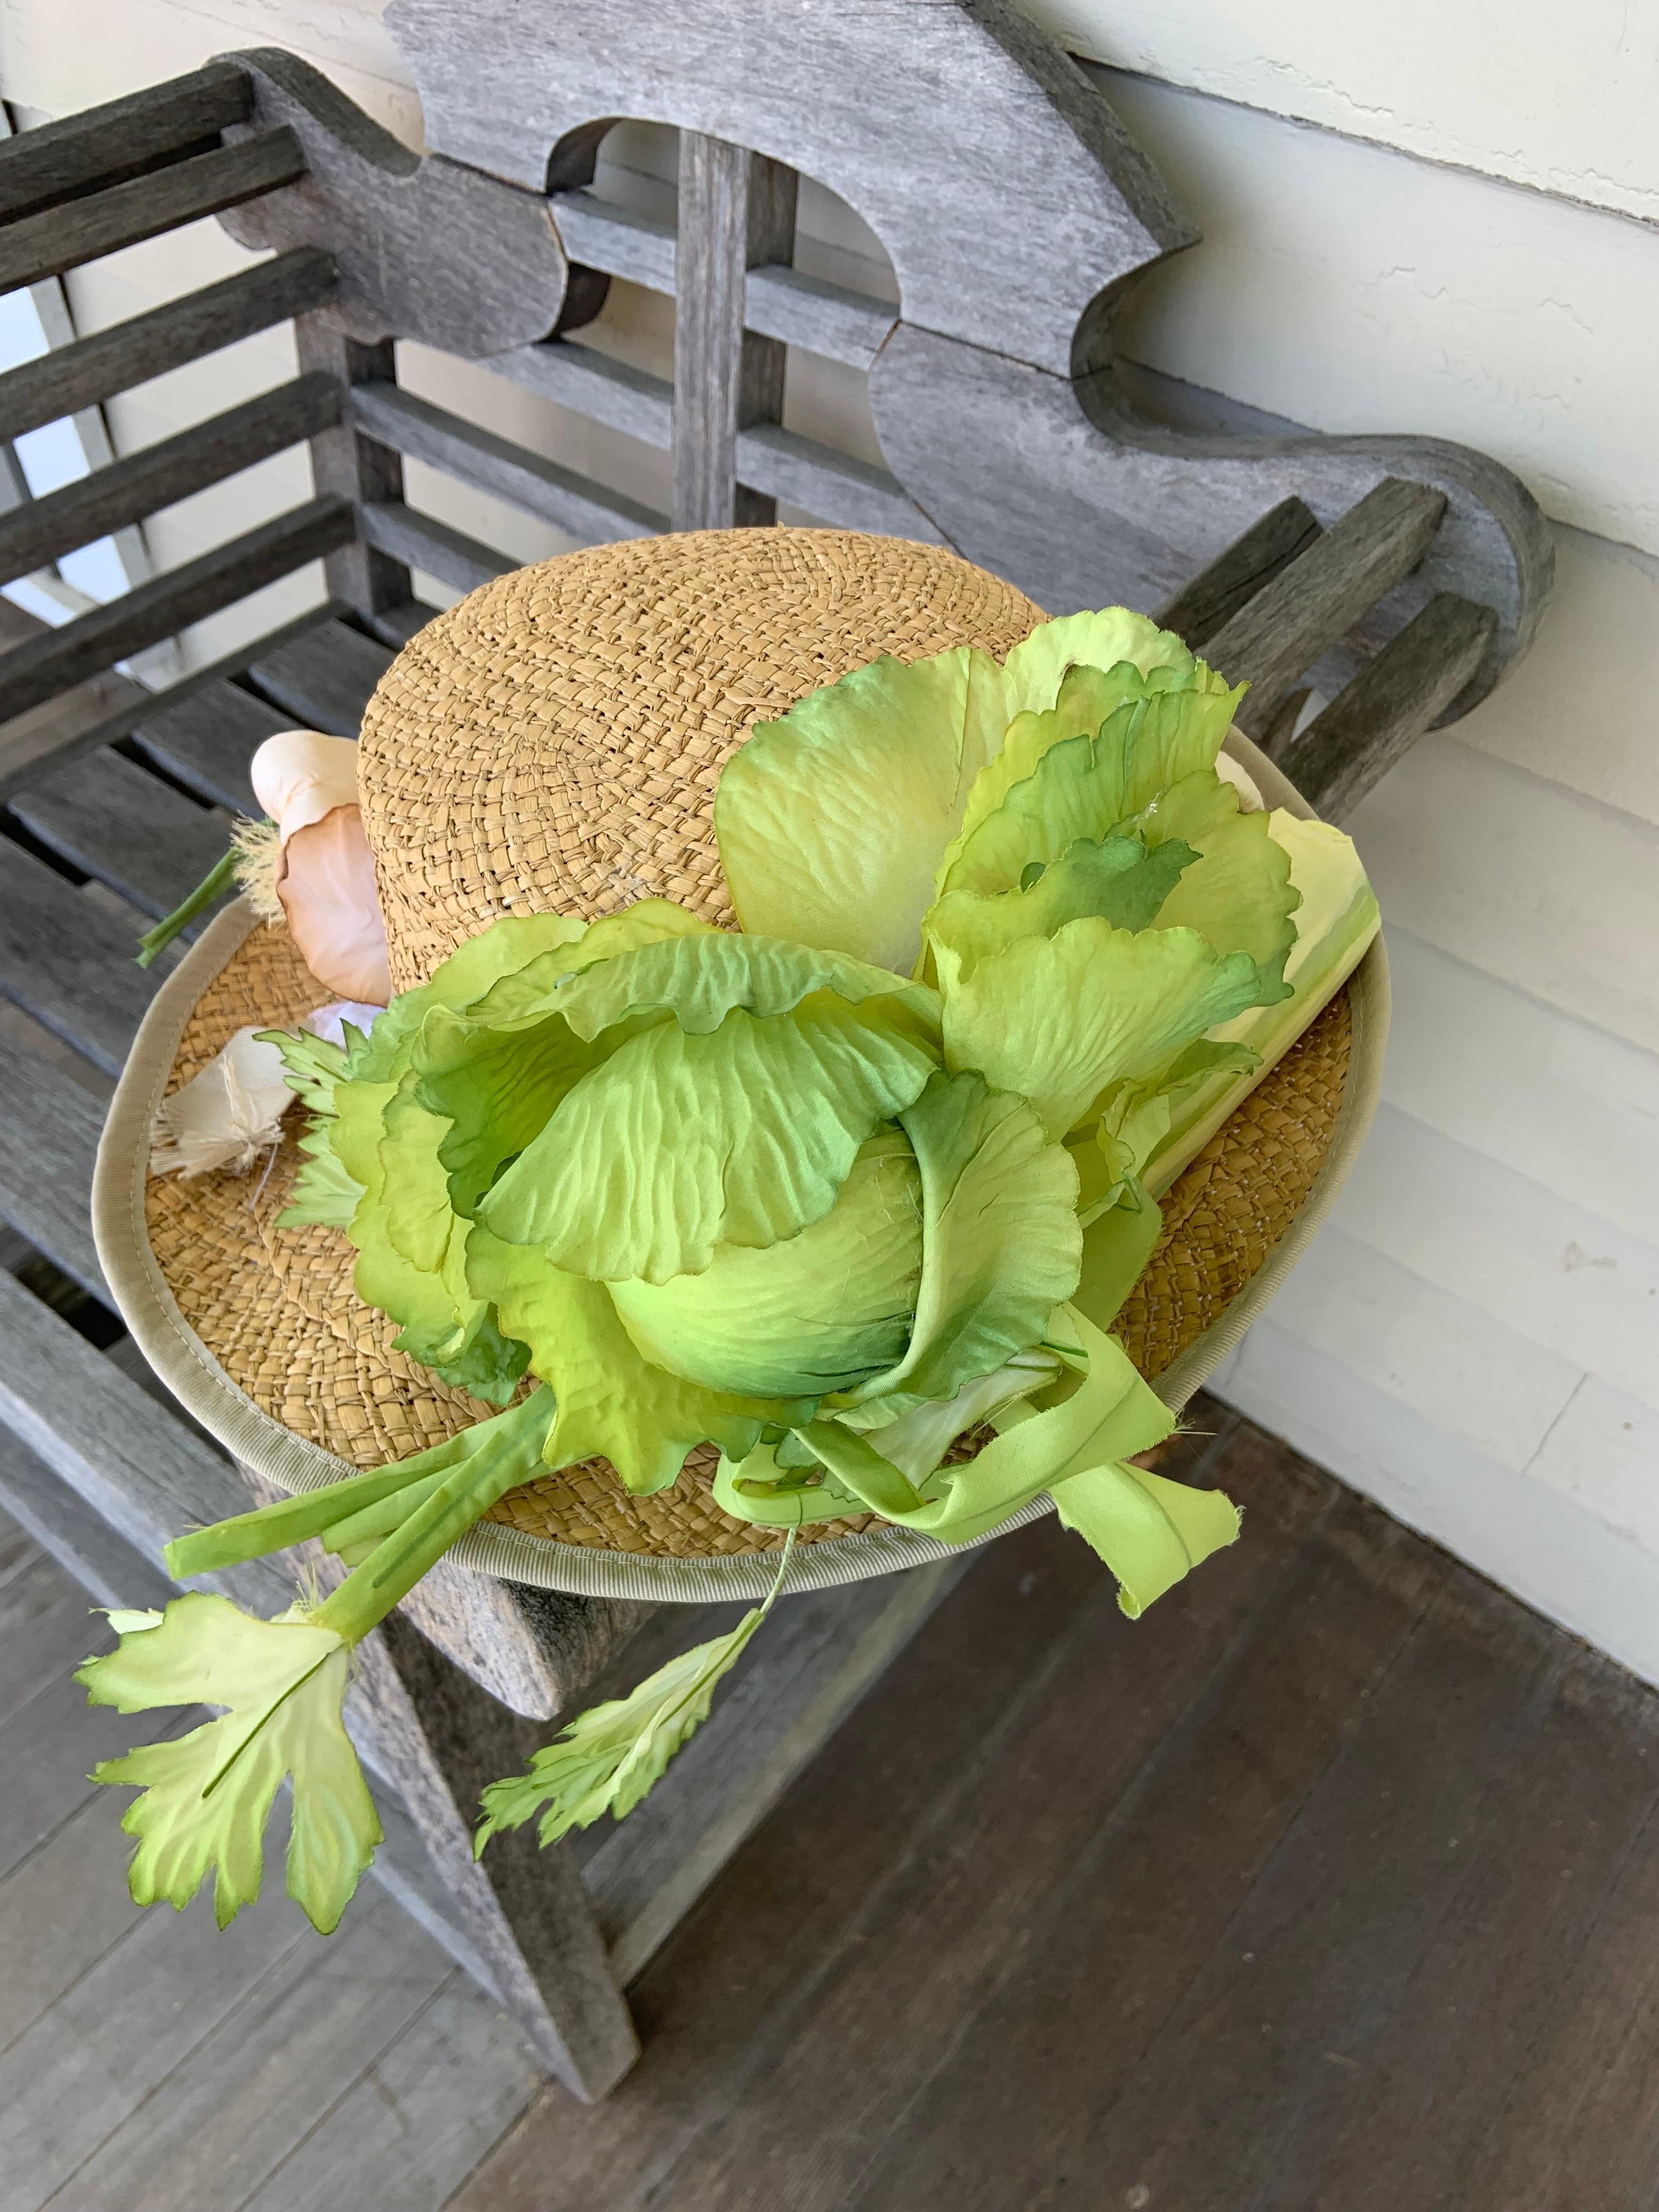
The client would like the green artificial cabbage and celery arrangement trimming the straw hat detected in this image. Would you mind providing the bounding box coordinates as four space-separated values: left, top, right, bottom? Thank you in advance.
88 608 1376 1925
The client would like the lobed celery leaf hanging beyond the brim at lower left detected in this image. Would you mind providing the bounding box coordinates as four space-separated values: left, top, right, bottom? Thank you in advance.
77 1593 381 1933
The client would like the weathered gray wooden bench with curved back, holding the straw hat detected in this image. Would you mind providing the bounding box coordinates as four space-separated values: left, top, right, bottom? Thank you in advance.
0 0 1550 2097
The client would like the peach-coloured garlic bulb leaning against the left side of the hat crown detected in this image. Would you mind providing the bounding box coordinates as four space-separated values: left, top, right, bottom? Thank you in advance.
250 730 392 1007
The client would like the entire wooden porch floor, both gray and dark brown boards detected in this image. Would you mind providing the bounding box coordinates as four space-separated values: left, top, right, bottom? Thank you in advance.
0 1423 1659 2212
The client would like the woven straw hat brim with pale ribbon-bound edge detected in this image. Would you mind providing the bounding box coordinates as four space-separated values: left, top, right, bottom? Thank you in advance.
93 732 1389 1601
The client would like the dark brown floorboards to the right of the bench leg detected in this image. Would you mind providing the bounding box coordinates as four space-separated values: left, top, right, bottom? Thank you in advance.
454 1425 1659 2212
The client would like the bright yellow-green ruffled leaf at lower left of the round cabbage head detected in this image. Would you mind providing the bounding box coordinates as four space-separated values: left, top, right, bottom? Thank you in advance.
469 1228 801 1496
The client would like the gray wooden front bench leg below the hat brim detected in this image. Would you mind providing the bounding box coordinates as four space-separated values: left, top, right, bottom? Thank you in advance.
352 1612 639 2103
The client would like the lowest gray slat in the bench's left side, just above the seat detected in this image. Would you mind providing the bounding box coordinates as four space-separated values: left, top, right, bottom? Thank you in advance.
0 498 354 719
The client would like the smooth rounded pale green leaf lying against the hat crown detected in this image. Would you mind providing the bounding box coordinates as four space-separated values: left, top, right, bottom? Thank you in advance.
714 648 1009 975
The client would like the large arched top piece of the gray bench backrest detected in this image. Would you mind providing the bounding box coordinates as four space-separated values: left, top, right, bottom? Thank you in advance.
387 0 1194 374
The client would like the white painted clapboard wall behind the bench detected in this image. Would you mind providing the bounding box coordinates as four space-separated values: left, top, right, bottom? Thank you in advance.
0 0 1659 1681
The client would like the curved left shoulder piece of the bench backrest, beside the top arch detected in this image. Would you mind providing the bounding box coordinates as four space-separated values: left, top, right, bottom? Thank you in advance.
225 47 566 358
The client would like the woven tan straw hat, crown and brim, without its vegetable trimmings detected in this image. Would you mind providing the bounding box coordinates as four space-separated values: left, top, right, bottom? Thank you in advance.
95 529 1387 1599
